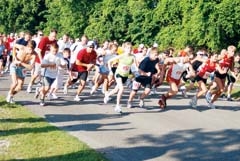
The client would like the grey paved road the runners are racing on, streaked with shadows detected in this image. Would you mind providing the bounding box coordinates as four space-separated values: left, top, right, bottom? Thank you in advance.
0 74 240 161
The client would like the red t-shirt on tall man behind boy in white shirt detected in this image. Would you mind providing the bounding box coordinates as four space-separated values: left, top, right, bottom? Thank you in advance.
35 37 57 63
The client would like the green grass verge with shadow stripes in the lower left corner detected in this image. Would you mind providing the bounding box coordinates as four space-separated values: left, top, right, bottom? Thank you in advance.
0 98 107 161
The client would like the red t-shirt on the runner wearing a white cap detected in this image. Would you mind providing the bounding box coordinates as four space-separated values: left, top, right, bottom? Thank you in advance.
72 48 97 72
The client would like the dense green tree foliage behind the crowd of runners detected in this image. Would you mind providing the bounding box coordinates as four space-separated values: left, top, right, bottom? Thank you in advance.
0 0 240 50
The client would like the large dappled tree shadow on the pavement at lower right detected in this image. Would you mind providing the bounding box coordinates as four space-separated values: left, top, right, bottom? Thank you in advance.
99 129 240 161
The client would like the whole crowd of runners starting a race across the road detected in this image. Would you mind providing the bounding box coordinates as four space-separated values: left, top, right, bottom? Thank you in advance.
0 29 240 113
